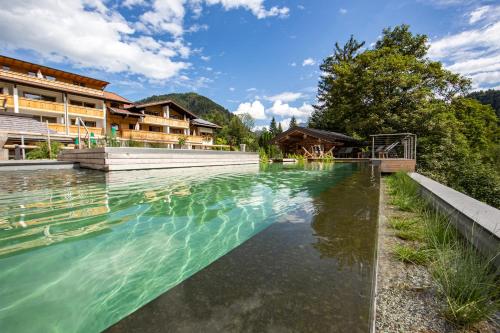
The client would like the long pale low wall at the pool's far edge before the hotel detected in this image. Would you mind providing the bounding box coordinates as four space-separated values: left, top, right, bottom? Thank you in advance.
58 147 259 171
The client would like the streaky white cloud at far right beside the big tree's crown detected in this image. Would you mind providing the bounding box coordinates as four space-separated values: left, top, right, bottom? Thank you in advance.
429 6 500 88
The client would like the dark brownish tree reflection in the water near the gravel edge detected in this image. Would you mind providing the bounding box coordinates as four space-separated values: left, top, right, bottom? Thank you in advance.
311 163 378 273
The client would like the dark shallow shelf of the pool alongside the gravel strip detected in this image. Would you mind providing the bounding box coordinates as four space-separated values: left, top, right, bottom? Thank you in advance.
108 164 378 333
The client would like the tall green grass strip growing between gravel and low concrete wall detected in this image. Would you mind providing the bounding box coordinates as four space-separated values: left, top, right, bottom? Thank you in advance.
387 173 500 326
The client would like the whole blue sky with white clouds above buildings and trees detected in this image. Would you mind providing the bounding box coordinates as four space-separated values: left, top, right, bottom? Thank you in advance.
0 0 500 127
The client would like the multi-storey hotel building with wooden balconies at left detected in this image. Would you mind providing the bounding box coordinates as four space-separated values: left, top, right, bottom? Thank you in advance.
0 55 220 152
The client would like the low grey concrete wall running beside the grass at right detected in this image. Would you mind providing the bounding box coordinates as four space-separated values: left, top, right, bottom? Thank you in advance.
409 172 500 267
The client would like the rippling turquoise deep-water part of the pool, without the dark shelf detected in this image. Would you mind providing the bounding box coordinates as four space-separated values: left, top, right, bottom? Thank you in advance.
0 164 357 332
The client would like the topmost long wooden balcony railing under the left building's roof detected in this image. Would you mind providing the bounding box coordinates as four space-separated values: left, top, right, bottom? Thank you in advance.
0 69 104 98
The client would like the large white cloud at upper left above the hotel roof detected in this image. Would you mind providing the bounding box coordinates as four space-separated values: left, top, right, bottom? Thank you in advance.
0 0 189 79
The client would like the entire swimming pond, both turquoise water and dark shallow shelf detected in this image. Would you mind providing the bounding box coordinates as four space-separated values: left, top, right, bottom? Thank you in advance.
0 163 378 332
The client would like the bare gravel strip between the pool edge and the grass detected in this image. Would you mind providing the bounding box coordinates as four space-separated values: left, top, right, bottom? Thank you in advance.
375 179 494 333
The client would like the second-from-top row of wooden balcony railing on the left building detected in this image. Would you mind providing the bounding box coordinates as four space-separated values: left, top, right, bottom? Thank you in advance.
0 95 104 119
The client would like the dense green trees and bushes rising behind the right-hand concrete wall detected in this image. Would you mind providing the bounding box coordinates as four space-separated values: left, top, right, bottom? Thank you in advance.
309 25 500 207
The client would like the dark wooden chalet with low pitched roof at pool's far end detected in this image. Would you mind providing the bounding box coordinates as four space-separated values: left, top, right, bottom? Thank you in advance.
271 127 365 159
